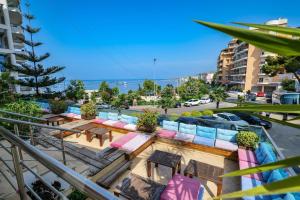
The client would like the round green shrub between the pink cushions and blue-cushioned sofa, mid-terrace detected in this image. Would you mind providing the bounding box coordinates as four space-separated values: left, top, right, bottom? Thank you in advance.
137 109 158 133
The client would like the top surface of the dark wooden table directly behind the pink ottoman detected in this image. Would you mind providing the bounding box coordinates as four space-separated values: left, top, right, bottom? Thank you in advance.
148 150 181 168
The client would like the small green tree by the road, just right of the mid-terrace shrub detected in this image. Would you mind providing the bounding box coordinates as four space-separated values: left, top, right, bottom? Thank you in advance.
158 85 176 114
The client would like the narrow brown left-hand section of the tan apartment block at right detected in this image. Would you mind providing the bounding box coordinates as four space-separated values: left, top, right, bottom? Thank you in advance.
217 39 238 84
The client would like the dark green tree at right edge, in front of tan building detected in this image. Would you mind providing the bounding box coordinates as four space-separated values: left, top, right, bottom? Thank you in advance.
262 56 300 83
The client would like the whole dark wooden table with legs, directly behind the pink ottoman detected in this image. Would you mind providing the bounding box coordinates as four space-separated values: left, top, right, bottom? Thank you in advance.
147 150 181 177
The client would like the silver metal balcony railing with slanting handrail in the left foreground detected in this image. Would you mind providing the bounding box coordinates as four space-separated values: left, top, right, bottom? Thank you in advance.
0 115 117 200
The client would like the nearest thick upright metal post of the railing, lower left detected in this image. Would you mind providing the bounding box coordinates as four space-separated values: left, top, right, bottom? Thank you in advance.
11 145 27 200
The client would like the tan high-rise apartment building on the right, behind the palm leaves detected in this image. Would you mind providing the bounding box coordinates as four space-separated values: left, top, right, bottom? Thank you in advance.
217 18 290 93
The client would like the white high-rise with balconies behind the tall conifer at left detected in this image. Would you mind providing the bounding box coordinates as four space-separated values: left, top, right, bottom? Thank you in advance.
0 0 31 93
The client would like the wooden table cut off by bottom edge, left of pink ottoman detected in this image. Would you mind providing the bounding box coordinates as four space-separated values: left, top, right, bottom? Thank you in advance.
114 174 166 200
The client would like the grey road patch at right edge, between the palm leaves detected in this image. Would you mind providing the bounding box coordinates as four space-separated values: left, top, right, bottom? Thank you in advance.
268 122 300 157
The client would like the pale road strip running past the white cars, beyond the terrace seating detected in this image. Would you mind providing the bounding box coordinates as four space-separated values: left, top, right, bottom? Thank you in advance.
130 102 236 114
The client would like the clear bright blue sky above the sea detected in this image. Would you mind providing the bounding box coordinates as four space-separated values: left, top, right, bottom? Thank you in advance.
27 0 300 80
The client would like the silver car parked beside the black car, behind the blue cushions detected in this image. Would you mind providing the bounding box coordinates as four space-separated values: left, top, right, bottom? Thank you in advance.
214 112 249 130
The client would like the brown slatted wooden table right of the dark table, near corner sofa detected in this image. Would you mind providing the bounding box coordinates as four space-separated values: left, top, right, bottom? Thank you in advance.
184 160 224 195
